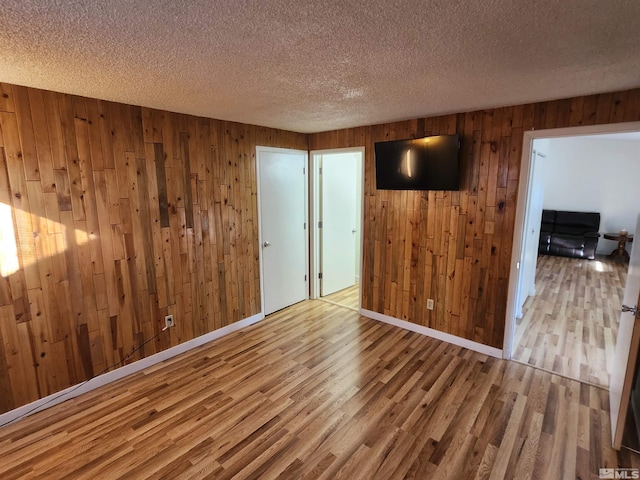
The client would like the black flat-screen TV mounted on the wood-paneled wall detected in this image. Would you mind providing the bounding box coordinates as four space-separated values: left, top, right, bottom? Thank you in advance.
375 135 460 190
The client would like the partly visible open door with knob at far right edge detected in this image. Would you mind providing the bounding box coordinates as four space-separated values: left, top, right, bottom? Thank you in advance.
609 215 640 449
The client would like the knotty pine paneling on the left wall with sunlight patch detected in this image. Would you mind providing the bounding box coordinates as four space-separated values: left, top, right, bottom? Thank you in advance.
0 84 308 412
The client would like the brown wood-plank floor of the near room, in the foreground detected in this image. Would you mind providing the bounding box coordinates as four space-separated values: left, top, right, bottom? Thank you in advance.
0 300 640 480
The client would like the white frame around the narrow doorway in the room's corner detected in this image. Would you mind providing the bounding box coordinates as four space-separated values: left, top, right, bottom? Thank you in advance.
309 147 365 306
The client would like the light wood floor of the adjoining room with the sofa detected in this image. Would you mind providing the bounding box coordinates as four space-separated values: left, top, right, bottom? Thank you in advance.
513 255 628 388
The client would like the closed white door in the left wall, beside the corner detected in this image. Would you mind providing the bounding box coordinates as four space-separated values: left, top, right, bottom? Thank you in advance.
256 147 308 315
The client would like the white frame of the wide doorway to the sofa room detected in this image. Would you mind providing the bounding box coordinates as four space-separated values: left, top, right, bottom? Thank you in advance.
502 122 640 359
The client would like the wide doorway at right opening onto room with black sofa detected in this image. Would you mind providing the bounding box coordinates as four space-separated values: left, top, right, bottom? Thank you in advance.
504 123 640 389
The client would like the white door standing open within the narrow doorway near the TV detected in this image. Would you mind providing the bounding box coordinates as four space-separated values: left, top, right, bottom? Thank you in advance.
320 153 361 296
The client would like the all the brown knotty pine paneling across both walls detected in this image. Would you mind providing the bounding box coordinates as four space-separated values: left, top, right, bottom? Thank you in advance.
0 80 640 411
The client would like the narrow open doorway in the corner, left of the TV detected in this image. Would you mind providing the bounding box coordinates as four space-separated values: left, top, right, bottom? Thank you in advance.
311 148 364 311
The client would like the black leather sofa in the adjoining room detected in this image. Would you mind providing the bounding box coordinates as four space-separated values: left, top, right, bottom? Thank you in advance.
538 210 600 260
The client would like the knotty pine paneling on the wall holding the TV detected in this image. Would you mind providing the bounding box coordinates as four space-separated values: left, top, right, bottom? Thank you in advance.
309 90 640 348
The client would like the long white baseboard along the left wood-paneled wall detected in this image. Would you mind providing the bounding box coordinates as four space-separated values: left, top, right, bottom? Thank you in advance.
0 313 264 425
